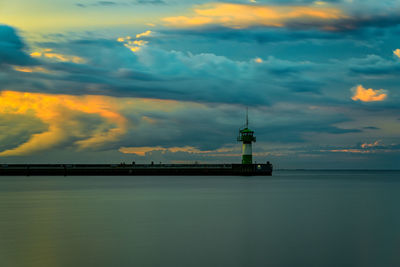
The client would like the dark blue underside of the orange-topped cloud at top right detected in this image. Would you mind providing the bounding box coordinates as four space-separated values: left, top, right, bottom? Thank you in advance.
159 0 400 43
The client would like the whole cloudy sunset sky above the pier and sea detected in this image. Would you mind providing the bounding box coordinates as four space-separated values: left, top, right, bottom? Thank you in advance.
0 0 400 169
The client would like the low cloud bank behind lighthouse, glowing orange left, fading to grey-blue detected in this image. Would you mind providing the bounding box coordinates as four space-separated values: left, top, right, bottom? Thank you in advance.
0 91 359 157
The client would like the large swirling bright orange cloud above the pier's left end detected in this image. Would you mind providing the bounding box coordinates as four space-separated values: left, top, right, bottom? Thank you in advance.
0 91 127 156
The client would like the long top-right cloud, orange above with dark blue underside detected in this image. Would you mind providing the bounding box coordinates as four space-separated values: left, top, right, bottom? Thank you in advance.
159 0 400 45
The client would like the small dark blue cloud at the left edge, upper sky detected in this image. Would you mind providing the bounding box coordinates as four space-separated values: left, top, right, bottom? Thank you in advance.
0 25 36 67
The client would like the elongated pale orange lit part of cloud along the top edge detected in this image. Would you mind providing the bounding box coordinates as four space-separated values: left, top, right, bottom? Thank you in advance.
163 3 347 28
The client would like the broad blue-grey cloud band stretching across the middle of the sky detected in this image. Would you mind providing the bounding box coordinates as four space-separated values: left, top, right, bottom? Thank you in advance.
4 25 398 112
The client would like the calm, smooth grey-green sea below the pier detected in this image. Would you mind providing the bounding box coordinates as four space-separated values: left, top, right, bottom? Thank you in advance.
0 170 400 267
